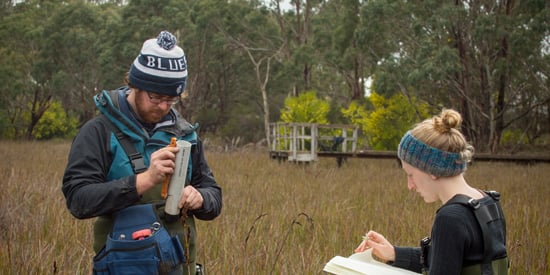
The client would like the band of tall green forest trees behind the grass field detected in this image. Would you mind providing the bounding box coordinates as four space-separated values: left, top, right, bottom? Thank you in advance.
0 0 550 148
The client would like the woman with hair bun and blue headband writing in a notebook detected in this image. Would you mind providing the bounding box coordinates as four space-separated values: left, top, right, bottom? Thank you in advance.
355 110 508 275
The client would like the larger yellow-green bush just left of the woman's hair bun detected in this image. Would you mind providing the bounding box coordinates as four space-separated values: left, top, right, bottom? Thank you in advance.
342 92 429 150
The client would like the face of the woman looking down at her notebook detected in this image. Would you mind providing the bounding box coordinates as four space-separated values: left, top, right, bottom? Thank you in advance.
401 161 439 203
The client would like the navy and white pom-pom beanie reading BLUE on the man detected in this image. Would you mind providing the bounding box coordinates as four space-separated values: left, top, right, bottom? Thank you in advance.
128 31 187 96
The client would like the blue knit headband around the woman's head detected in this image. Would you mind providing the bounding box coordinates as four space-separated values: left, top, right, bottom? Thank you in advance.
397 131 466 177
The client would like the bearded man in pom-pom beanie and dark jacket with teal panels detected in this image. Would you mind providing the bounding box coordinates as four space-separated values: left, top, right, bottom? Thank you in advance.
62 31 222 274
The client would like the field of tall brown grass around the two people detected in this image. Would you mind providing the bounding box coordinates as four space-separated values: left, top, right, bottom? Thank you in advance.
0 141 550 274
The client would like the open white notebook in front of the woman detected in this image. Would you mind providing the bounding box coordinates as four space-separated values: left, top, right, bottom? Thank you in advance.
323 249 419 275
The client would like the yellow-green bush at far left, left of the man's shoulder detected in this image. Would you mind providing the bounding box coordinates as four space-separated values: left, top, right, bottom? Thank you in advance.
25 101 78 140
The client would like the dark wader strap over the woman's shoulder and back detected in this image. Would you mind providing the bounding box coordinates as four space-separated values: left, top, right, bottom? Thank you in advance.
446 191 503 274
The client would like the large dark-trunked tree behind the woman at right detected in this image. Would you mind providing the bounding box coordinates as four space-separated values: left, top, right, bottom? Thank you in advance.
365 0 548 152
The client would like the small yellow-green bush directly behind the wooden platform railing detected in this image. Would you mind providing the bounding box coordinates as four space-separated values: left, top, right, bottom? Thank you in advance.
281 91 330 124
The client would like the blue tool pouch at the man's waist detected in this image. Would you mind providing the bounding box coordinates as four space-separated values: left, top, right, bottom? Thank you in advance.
93 204 185 274
